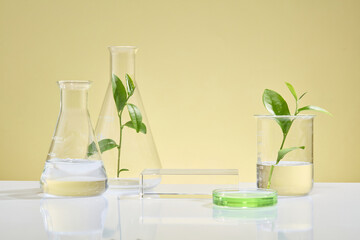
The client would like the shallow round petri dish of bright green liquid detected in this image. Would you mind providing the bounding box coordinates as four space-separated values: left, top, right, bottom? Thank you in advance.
213 188 277 208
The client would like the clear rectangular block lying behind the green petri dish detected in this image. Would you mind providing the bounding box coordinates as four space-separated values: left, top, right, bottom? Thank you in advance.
140 169 239 198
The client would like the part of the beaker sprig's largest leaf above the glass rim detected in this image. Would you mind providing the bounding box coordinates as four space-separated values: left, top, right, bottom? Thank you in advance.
263 89 290 115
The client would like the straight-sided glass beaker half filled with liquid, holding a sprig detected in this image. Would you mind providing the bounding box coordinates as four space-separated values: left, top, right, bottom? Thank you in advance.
255 115 314 196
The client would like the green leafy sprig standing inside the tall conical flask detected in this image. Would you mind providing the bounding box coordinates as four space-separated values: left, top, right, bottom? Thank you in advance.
88 74 147 177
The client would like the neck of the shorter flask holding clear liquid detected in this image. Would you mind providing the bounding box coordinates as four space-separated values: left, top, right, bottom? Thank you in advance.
59 81 90 111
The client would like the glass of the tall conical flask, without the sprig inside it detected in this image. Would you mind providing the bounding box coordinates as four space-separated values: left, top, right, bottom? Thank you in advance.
95 46 161 190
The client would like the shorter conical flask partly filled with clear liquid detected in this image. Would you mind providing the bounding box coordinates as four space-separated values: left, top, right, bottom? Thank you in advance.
40 81 108 196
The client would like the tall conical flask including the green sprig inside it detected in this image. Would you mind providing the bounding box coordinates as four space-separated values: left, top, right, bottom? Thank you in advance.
95 46 161 189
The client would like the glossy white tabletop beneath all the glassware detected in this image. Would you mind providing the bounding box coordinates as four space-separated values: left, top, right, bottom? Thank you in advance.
0 181 360 240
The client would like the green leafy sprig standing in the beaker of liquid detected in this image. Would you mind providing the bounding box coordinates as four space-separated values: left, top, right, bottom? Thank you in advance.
262 82 331 188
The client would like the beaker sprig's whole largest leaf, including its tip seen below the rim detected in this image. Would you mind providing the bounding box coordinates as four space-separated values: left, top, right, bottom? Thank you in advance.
263 89 292 135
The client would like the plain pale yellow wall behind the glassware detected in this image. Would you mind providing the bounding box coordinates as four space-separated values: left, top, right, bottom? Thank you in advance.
0 0 360 182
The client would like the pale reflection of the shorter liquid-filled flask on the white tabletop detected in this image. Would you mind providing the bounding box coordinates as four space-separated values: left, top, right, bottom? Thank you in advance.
40 196 108 240
